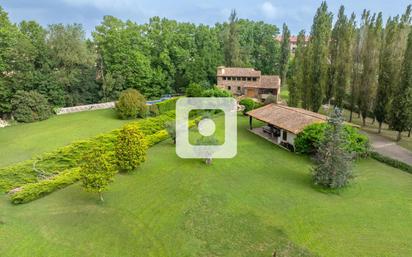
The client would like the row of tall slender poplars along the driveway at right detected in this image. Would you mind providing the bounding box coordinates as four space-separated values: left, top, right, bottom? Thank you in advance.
289 2 412 140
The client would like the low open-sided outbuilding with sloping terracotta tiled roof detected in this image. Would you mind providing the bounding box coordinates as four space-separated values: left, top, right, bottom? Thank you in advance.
247 104 328 151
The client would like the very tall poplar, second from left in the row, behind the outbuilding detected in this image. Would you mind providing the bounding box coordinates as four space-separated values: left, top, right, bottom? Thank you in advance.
308 2 332 111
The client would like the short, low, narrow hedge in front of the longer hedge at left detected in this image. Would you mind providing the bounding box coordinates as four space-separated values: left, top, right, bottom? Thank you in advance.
10 168 80 204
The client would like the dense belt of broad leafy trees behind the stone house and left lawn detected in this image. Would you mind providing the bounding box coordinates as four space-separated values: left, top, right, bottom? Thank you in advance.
0 7 280 118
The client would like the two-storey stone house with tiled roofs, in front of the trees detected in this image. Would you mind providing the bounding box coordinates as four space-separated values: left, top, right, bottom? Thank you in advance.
216 66 280 100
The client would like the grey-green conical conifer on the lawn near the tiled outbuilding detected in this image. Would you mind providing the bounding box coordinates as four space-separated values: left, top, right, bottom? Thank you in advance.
312 107 353 188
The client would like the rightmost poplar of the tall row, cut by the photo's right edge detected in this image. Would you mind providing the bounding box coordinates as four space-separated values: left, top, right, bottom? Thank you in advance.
389 29 412 141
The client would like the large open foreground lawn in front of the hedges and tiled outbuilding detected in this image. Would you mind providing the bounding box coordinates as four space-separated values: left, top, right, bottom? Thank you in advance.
0 117 412 257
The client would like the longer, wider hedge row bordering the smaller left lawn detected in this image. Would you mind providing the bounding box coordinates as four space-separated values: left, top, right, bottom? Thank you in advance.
0 112 175 192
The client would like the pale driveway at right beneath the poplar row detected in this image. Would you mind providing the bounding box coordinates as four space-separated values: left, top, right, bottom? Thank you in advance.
362 131 412 165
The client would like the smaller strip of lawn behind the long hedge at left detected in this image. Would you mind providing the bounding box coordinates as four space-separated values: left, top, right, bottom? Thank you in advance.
0 109 127 167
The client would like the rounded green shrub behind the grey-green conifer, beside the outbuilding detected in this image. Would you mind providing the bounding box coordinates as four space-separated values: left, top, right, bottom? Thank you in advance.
294 123 369 157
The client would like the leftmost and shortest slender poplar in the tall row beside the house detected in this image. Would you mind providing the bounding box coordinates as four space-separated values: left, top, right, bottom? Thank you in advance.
288 30 306 107
